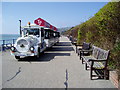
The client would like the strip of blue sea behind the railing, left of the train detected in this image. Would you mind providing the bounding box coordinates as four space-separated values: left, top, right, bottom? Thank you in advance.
0 34 20 45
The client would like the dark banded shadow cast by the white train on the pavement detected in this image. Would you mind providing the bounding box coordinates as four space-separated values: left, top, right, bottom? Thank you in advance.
19 42 74 62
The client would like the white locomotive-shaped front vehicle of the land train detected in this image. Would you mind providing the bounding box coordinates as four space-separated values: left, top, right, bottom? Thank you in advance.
11 25 46 59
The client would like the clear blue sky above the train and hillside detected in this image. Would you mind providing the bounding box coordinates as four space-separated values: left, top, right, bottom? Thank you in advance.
0 2 108 34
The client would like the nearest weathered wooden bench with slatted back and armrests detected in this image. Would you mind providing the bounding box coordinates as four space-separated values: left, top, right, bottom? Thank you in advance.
82 46 109 80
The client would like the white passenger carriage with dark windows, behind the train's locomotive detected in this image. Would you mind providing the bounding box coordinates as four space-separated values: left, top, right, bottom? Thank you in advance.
44 28 60 48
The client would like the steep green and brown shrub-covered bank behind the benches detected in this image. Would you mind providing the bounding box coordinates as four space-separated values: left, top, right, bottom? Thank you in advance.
65 2 120 78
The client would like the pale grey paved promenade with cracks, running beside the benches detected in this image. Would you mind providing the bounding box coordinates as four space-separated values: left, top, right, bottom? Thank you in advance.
2 37 115 88
